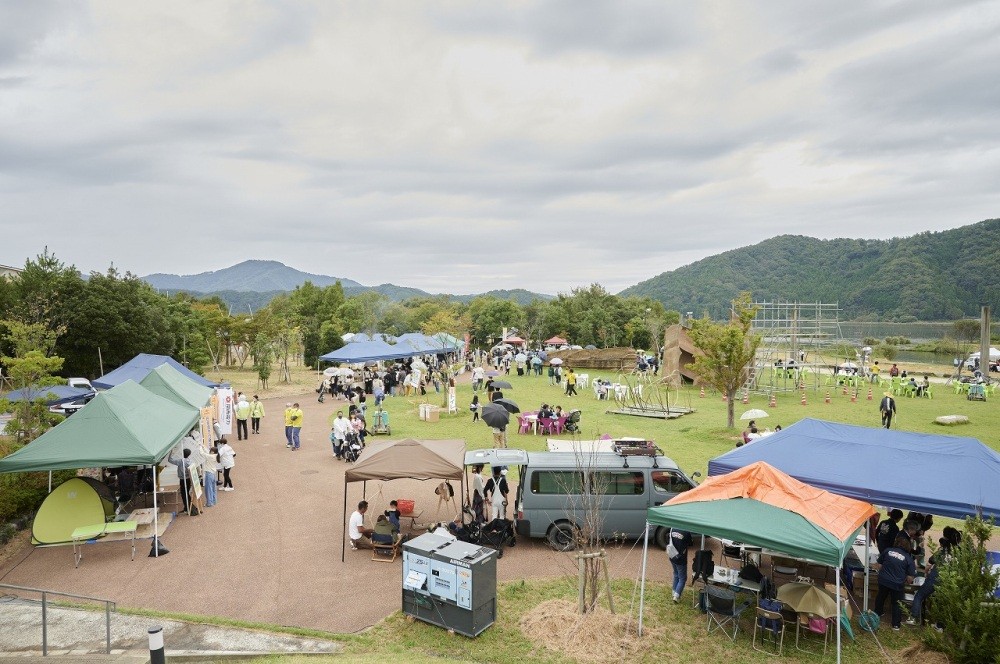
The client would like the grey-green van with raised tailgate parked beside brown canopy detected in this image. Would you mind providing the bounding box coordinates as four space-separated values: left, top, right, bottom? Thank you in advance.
466 449 695 551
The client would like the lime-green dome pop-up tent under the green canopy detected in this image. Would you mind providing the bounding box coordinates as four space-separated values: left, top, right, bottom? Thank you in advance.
31 477 115 544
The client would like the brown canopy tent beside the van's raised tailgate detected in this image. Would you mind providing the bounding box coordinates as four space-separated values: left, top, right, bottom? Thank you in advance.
340 438 465 562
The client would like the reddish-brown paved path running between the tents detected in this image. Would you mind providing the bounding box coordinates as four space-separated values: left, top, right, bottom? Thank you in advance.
0 394 669 633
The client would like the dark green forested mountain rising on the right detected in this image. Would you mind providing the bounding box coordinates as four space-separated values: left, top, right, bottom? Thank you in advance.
621 219 1000 321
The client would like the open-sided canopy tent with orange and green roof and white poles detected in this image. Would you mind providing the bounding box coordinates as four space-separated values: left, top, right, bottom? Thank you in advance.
639 463 875 662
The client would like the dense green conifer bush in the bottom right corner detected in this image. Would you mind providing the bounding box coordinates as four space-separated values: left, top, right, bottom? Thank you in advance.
925 517 1000 664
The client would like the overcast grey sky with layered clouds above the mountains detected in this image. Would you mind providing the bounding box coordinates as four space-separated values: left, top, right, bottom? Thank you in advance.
0 0 1000 294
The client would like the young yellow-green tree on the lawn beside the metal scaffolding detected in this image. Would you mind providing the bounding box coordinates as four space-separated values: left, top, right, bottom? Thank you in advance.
691 291 760 429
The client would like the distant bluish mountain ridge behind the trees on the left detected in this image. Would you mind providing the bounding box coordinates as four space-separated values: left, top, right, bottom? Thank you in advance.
142 260 553 312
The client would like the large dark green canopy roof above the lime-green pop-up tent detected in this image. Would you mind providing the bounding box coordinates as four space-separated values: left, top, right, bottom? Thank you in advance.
0 380 200 473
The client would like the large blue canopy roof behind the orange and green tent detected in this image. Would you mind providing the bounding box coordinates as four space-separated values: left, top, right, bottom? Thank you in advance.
708 419 1000 518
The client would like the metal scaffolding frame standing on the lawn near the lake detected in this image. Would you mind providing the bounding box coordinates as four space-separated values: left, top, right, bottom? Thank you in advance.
744 300 844 394
